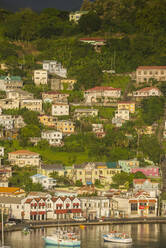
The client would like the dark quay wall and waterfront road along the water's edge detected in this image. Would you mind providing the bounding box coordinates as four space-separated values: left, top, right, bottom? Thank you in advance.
3 217 166 232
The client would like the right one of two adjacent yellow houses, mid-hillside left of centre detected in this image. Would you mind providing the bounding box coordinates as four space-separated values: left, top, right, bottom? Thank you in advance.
55 120 75 134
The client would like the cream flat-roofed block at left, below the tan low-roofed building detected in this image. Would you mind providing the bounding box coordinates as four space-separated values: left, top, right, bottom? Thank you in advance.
20 99 42 113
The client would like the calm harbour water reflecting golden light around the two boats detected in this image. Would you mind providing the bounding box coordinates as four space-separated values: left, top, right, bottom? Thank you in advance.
2 224 166 248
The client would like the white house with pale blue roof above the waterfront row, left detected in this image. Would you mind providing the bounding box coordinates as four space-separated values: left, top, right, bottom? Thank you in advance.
30 174 56 189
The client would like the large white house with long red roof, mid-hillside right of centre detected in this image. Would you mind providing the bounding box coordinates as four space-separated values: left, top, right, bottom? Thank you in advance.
84 86 121 104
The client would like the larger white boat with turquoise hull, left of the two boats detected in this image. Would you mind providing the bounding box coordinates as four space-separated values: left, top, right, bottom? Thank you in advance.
43 233 81 247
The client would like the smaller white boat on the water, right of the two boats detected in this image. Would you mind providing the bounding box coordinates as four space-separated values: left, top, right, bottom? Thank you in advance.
103 232 133 244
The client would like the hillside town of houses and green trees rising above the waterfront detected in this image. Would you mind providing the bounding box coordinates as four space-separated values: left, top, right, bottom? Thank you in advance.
0 2 166 232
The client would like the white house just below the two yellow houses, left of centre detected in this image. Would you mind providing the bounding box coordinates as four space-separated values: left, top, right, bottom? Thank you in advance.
41 130 62 145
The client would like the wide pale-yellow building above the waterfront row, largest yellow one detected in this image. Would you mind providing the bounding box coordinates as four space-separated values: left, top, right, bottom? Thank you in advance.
73 162 121 185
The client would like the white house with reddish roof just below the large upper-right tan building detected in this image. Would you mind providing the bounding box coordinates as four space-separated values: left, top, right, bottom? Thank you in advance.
133 87 162 97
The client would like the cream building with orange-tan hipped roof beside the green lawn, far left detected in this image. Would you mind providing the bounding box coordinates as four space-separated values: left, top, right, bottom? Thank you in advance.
8 150 40 167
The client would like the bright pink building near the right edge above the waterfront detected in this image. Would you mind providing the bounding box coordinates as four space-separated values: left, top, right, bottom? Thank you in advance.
131 167 160 177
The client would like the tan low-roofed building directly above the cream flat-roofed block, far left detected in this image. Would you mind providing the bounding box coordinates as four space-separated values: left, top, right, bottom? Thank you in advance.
6 89 34 100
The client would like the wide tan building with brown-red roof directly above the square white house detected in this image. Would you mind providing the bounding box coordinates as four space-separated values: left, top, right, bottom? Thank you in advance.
42 91 69 103
